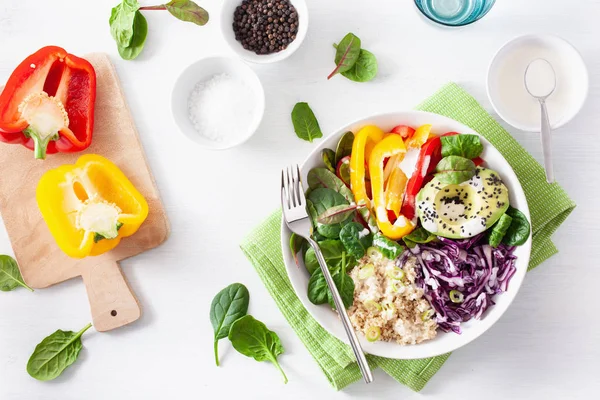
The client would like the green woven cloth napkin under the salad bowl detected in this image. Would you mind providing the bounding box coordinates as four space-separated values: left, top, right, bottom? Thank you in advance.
241 83 575 391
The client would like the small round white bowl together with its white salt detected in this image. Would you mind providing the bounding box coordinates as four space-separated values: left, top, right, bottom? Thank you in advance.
171 57 265 150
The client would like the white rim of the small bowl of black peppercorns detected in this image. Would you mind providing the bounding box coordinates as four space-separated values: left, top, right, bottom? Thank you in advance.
219 0 309 64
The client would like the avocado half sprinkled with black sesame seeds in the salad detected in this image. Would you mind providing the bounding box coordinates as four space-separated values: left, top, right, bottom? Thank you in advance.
417 167 509 239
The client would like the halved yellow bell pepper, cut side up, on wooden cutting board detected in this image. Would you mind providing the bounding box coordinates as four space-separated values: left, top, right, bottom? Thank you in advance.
36 154 148 258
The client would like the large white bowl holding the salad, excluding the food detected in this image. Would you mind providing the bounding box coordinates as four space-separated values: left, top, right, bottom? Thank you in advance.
281 111 531 359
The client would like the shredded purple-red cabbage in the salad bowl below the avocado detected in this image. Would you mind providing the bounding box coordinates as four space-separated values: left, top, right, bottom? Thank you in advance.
398 234 517 334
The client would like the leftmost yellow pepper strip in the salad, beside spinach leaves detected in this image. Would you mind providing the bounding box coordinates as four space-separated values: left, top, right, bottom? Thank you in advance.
350 125 384 207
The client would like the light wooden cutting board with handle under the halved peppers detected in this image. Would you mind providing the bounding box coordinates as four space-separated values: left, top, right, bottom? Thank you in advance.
0 53 169 331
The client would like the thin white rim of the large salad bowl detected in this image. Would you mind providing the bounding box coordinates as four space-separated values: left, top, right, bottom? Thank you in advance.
280 110 532 359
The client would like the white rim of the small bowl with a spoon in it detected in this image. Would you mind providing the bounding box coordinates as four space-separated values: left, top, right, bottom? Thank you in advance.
485 33 590 133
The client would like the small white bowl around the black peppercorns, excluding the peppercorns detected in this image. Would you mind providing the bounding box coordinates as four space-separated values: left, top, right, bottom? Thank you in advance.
220 0 308 64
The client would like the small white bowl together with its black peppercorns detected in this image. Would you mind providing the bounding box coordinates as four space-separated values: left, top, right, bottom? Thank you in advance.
221 0 308 64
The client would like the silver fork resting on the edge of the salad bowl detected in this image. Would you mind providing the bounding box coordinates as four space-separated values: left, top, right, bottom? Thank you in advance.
281 165 373 383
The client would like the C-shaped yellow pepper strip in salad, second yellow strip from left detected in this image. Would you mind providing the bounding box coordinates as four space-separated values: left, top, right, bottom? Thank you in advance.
369 135 415 240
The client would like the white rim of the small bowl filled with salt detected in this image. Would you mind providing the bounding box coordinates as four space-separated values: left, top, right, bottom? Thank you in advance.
171 56 266 150
